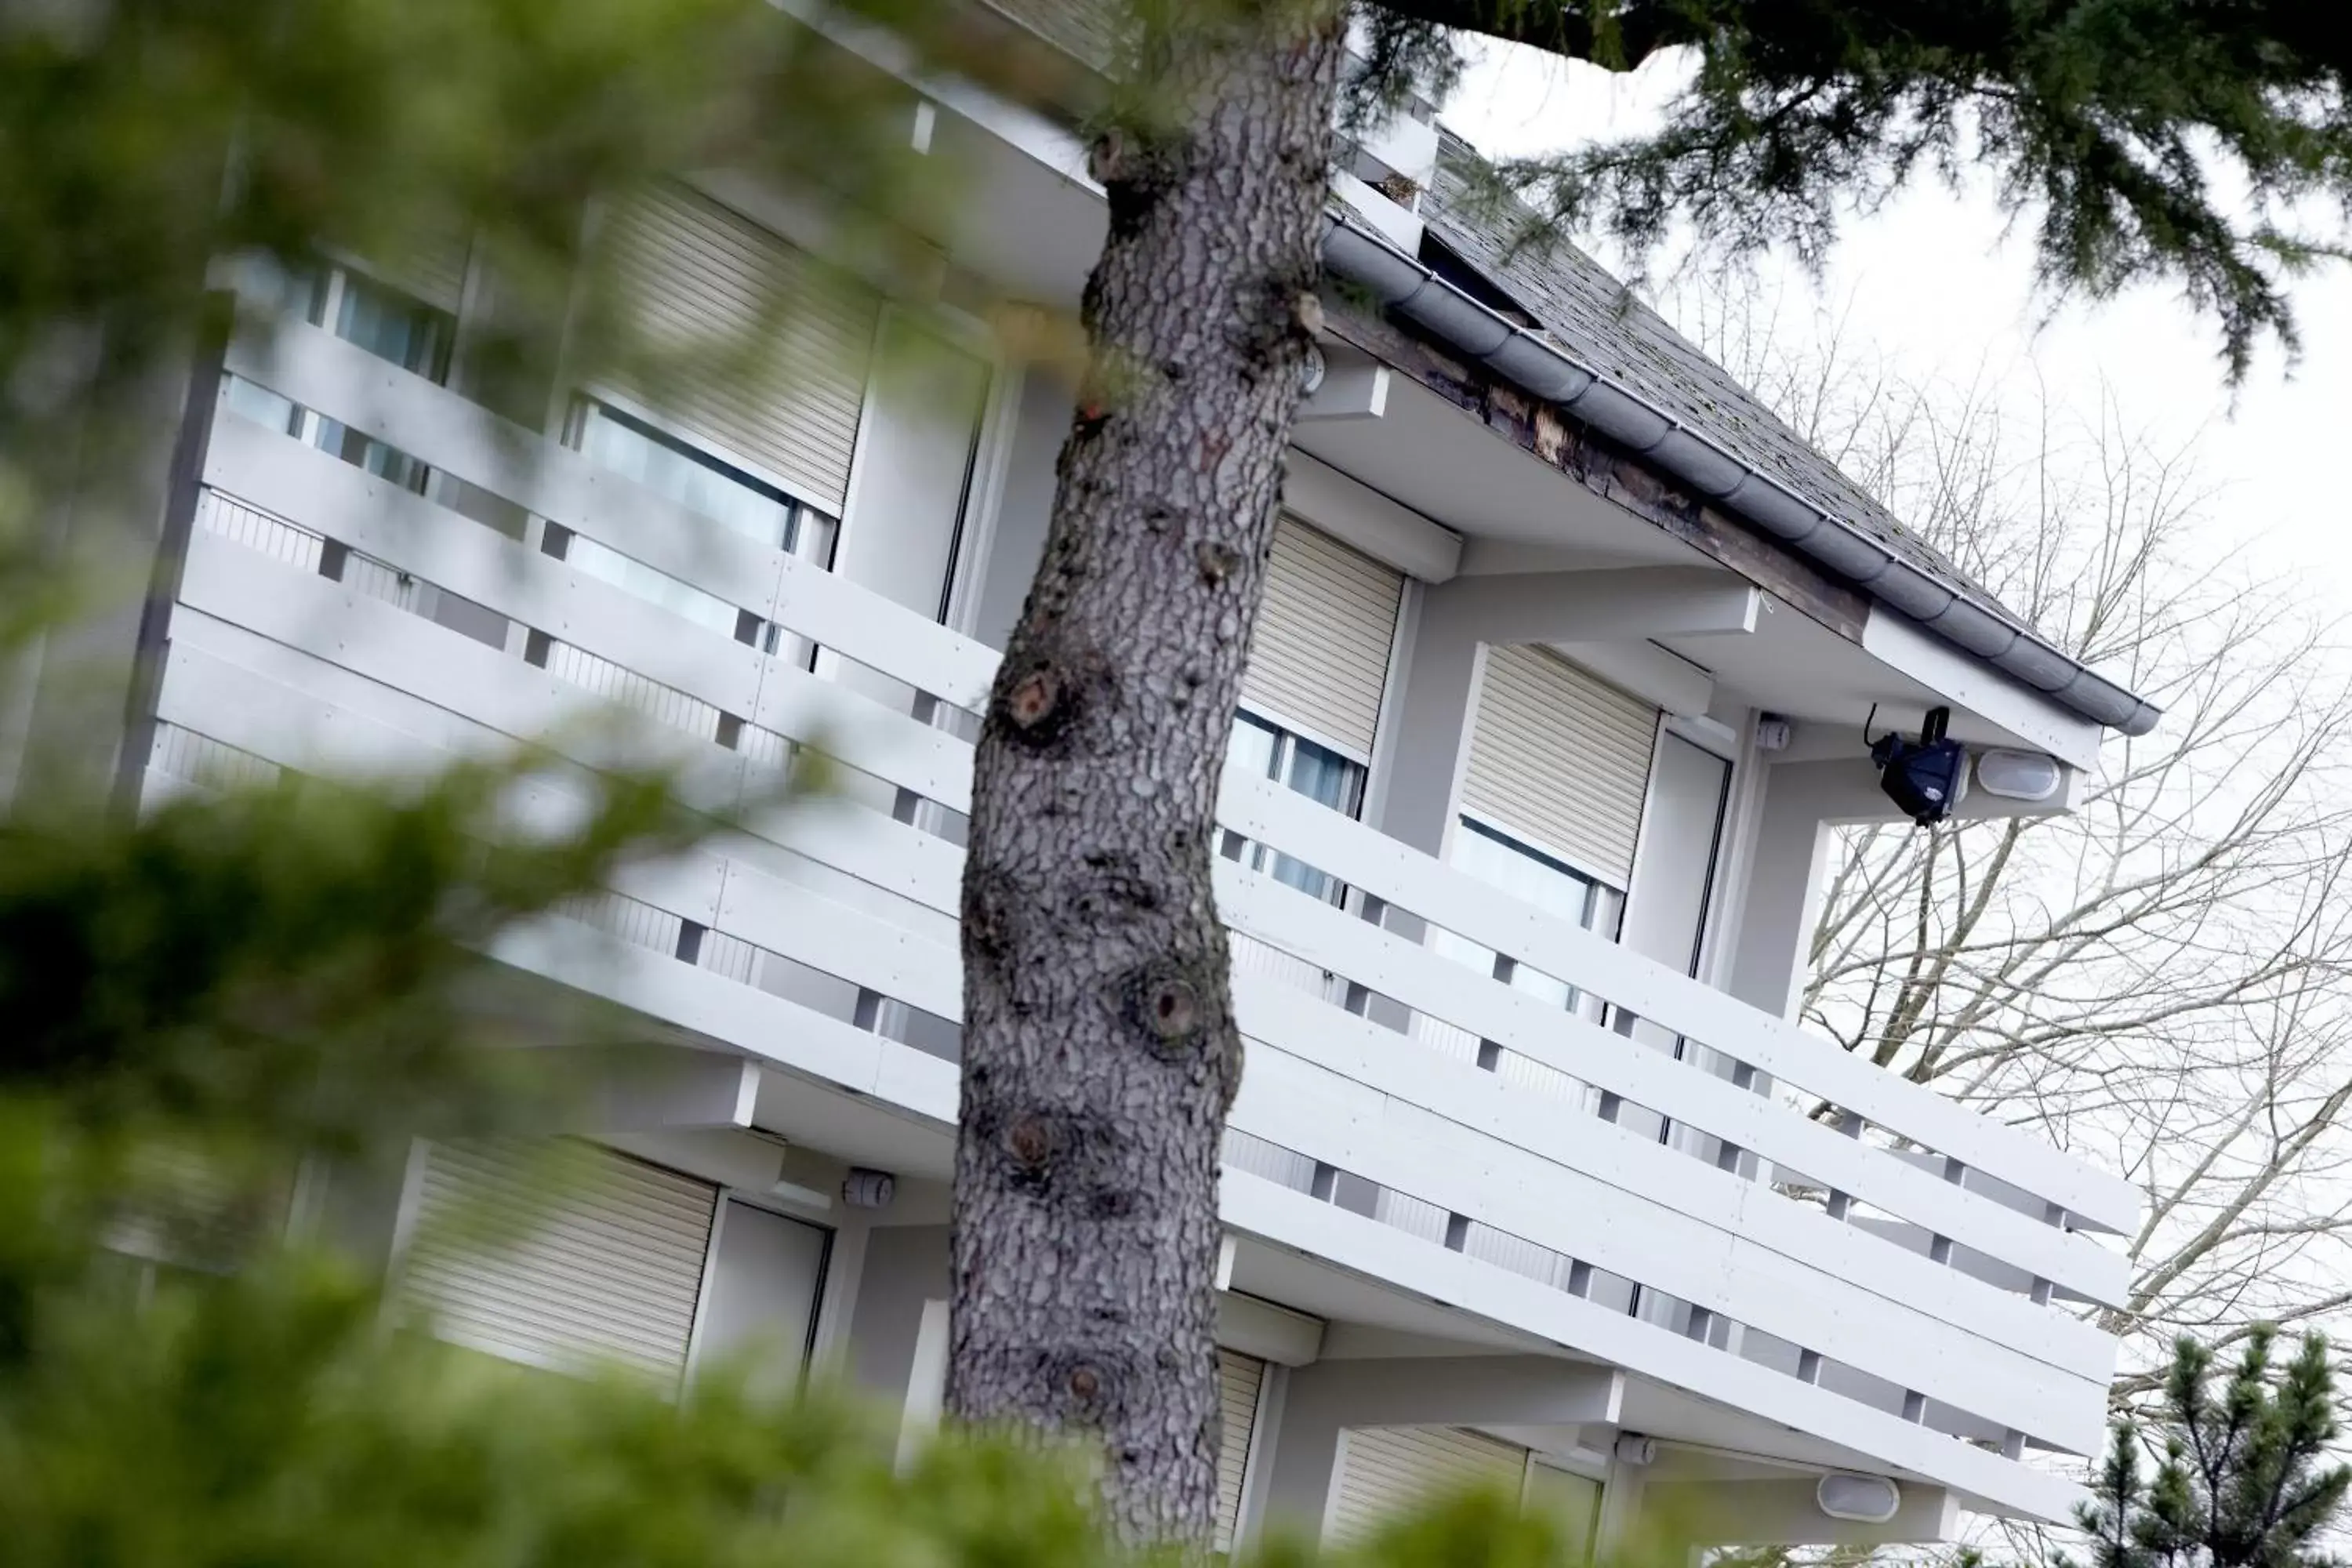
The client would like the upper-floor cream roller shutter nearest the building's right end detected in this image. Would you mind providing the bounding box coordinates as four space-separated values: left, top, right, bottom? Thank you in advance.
1463 644 1658 891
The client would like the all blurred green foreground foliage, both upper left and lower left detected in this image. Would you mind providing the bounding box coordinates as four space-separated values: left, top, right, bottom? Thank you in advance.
0 0 1557 1568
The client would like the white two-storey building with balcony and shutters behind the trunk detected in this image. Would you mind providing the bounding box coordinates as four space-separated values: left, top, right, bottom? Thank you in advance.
18 2 2154 1542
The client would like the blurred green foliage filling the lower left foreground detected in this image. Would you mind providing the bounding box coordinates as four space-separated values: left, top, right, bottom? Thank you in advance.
0 760 1559 1568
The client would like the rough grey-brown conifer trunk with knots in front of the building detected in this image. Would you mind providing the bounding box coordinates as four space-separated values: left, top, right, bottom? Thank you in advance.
948 0 1343 1544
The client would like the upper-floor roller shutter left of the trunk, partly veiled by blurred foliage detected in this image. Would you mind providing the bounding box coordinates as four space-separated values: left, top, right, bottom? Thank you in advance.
602 186 880 513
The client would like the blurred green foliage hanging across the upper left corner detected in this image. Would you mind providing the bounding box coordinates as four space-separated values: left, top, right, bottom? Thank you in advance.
0 0 1068 686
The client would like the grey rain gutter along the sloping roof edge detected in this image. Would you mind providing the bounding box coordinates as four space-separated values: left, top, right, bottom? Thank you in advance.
1322 209 2161 736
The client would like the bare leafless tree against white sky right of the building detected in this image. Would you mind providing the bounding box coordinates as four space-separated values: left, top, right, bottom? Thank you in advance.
1677 285 2352 1403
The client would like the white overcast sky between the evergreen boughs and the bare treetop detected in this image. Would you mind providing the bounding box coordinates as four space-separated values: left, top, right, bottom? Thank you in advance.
1442 45 2352 612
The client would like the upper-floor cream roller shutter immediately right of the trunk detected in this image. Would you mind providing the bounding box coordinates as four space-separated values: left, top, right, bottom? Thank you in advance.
1242 517 1404 755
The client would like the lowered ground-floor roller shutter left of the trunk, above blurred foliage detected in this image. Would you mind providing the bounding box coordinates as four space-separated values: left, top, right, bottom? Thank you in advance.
400 1142 717 1382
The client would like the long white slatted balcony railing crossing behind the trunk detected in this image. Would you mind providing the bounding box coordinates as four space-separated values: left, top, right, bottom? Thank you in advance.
151 312 2136 1516
